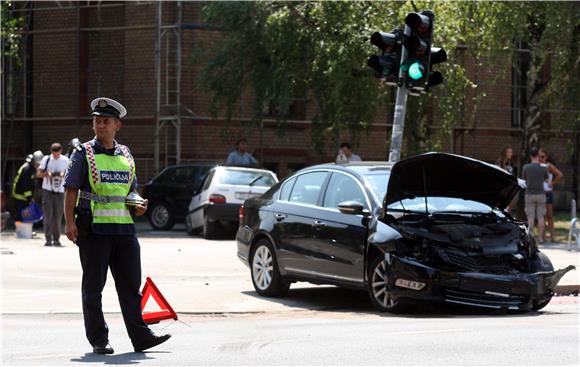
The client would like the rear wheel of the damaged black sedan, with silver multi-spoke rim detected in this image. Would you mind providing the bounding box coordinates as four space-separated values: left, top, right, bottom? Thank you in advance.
250 238 290 297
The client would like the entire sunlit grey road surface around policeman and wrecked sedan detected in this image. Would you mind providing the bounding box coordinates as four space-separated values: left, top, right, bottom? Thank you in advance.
0 224 580 366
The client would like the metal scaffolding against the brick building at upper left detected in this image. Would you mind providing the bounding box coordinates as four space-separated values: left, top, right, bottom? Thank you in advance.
2 0 197 180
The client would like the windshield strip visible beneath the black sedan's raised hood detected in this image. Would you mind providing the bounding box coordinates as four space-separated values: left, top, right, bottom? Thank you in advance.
387 196 493 214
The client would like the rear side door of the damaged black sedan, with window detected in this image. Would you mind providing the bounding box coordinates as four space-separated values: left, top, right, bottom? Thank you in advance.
270 170 328 273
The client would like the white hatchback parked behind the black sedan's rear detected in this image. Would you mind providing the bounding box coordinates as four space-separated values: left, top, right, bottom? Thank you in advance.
185 166 278 238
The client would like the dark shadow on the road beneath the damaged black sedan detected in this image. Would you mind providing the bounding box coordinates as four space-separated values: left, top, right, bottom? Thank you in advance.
242 286 552 318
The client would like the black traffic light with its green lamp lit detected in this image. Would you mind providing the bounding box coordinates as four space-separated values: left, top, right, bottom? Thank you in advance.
402 10 447 95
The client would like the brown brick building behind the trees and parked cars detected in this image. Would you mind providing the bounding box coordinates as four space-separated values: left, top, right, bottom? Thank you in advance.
1 1 580 207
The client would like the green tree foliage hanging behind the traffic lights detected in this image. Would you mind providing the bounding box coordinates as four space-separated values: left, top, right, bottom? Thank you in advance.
195 1 580 158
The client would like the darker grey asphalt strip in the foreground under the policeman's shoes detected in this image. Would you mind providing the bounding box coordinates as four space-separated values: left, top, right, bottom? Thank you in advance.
2 303 579 366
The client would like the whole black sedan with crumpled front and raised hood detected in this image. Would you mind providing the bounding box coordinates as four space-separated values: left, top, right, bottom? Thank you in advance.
237 153 574 312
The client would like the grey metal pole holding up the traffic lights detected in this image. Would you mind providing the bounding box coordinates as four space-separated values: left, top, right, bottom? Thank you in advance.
389 25 411 163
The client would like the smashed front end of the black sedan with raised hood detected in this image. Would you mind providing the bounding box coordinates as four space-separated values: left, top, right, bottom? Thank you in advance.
369 153 574 311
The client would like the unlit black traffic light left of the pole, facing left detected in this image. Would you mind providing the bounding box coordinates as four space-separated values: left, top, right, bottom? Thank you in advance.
367 29 403 85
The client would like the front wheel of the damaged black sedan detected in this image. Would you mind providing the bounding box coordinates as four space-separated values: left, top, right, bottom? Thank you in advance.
367 254 406 313
